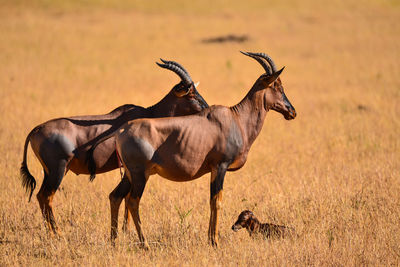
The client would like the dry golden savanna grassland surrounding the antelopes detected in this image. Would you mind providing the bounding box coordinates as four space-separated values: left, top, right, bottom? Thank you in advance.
0 0 400 266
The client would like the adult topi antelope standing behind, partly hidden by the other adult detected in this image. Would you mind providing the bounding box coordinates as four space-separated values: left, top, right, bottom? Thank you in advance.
20 59 208 234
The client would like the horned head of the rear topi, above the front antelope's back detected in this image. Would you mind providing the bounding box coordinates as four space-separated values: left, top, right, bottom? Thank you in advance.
156 59 208 116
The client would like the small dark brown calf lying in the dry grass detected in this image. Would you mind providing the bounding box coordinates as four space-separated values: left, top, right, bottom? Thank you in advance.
232 210 294 238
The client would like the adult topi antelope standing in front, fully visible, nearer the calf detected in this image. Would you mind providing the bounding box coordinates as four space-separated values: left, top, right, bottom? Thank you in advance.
111 52 296 248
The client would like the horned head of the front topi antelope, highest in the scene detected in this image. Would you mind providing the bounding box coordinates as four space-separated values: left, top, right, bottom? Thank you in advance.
241 52 296 120
